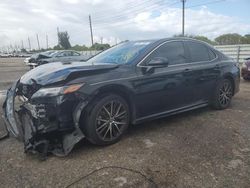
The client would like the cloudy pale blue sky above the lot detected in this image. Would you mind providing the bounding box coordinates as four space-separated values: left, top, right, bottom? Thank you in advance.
0 0 250 49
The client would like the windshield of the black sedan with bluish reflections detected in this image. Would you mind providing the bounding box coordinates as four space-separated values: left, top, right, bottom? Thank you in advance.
88 41 152 64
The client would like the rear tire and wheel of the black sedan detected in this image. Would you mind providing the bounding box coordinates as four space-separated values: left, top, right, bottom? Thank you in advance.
212 79 233 110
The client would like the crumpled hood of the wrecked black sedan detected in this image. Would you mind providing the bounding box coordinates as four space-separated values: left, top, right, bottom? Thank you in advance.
20 62 118 85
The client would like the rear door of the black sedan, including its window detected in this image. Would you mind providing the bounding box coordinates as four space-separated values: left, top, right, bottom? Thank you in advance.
184 41 220 103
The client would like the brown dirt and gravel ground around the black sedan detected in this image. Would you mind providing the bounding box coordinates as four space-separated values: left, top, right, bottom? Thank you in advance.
0 59 250 188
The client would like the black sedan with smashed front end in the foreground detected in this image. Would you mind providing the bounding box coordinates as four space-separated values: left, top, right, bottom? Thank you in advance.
3 38 240 156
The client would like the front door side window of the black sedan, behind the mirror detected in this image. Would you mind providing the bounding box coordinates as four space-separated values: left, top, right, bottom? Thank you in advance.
146 41 186 65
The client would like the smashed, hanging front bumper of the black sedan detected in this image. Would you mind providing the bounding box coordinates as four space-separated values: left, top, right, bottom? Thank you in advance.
3 81 87 156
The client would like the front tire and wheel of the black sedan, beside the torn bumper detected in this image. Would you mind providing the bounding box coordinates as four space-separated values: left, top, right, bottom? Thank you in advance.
82 94 130 145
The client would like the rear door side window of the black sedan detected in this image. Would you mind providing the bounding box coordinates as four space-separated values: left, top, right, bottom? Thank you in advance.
186 41 210 62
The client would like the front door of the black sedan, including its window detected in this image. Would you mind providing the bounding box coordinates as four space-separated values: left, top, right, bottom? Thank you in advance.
134 41 192 118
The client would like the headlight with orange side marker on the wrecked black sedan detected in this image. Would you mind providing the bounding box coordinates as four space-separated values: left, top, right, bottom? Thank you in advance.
32 84 84 98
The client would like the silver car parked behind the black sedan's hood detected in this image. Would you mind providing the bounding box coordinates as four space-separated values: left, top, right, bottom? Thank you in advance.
35 50 90 66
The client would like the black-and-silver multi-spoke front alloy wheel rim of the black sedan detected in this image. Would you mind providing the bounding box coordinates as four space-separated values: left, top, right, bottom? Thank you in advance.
96 101 128 141
